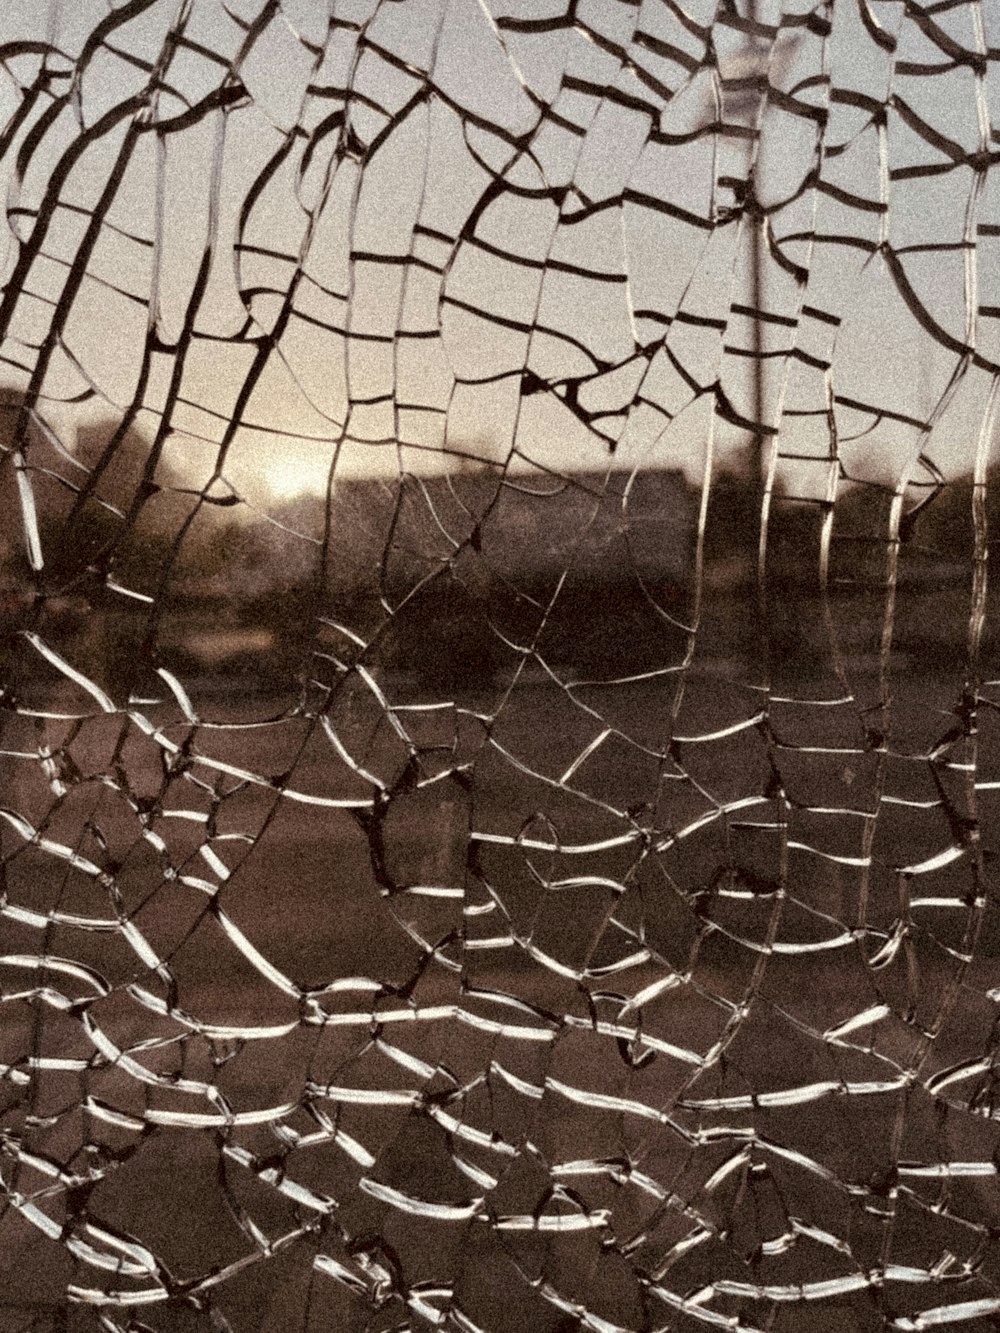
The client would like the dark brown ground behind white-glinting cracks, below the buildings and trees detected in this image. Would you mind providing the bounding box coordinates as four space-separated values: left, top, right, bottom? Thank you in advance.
0 672 1000 1333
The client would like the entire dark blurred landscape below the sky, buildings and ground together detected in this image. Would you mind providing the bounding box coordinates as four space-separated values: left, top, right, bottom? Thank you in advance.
0 405 1000 1333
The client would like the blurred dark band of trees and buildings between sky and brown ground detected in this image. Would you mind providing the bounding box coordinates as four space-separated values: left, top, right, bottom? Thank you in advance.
0 393 1000 701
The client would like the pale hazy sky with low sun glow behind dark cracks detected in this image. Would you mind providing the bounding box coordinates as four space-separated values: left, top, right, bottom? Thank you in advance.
0 0 1000 503
